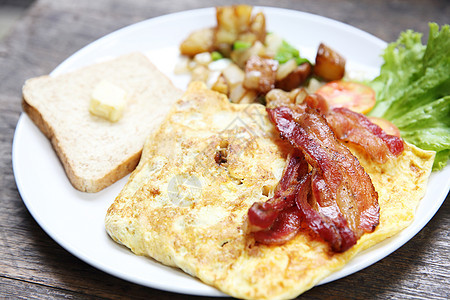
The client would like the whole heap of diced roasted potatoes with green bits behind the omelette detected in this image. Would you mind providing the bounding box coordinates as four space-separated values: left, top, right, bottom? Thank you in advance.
177 5 318 103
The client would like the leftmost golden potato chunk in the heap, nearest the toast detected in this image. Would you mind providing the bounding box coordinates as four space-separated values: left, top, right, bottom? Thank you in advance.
180 28 214 56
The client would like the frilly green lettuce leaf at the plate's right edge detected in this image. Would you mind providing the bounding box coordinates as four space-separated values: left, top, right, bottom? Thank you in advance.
368 23 450 170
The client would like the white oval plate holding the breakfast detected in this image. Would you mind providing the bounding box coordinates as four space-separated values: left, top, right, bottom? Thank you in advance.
13 7 450 296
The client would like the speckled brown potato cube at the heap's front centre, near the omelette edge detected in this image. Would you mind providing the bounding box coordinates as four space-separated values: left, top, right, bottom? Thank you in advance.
244 56 278 94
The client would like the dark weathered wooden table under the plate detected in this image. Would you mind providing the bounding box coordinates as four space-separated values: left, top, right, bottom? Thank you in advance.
0 0 450 299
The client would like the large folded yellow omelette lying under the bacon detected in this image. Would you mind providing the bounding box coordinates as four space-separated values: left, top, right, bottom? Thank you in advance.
105 82 434 299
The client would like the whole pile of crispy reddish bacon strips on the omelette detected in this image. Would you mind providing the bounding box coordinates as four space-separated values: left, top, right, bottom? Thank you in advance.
248 94 392 252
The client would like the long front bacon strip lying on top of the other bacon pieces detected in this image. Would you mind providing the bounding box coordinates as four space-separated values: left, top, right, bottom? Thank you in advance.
268 104 379 252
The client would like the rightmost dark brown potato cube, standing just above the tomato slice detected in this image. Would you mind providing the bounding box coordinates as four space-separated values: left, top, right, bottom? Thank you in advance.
314 43 345 81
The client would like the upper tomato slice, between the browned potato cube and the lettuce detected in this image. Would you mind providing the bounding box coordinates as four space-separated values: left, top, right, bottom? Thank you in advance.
316 80 375 114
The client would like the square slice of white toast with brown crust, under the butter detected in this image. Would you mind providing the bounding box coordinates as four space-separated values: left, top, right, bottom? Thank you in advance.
22 53 181 192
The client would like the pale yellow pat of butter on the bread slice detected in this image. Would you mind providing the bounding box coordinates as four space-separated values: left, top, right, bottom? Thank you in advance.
89 80 126 122
